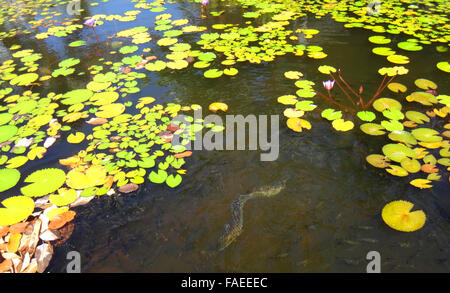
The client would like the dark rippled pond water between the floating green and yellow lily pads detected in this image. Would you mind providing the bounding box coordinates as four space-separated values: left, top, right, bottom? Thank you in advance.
0 0 450 272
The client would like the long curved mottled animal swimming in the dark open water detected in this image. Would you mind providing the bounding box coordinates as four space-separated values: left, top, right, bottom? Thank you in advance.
219 181 286 251
